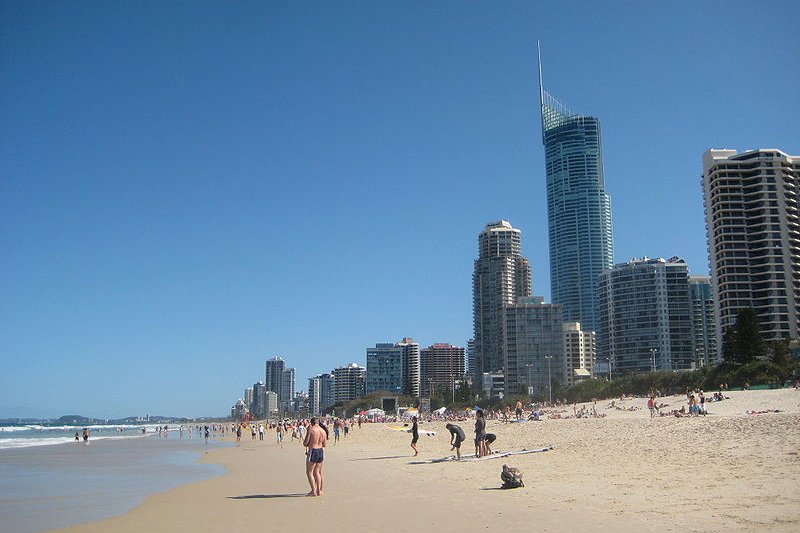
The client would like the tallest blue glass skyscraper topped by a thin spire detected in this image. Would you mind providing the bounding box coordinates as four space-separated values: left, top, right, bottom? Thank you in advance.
539 45 614 331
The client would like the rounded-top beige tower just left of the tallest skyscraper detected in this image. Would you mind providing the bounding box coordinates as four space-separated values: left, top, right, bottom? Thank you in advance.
470 220 532 390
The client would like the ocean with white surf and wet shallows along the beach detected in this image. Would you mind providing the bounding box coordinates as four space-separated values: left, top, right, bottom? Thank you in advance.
0 425 230 533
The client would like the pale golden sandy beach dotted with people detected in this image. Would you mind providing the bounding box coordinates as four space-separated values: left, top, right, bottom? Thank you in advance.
45 389 800 533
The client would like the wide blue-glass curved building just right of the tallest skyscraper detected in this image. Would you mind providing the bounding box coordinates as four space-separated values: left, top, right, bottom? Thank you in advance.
597 257 694 373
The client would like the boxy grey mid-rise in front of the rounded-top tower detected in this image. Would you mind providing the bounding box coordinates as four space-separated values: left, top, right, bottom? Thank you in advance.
503 296 566 396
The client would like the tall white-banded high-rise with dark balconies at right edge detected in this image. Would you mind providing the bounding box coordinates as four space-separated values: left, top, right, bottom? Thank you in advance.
703 149 800 351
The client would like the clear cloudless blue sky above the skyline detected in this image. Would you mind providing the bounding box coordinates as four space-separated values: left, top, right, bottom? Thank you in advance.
0 1 800 418
